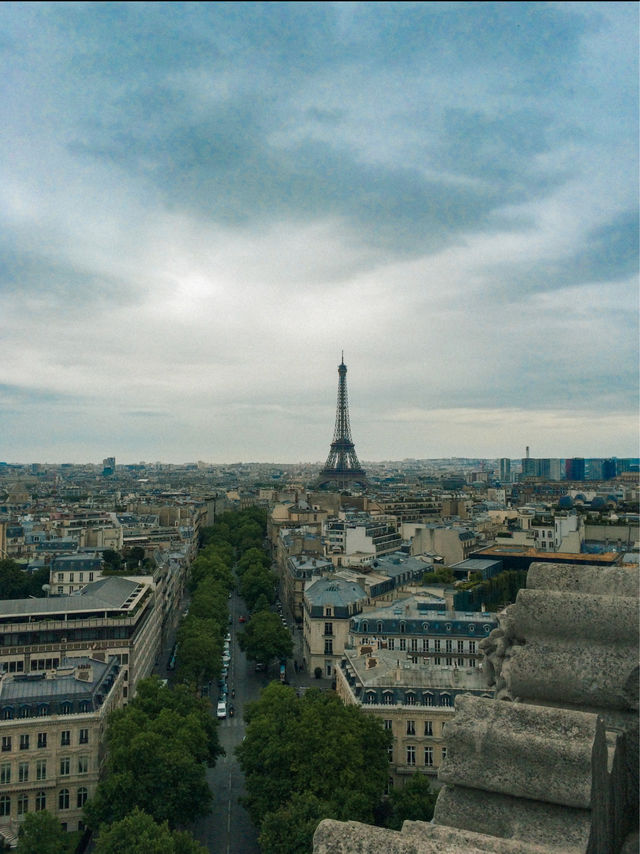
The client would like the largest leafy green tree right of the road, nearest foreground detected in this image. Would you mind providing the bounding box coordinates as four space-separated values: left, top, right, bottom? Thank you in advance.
236 682 391 854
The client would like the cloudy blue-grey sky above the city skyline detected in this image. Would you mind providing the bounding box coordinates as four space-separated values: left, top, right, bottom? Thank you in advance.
0 2 638 462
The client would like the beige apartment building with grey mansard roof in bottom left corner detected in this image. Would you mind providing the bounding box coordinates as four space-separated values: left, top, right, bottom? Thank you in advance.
0 653 125 847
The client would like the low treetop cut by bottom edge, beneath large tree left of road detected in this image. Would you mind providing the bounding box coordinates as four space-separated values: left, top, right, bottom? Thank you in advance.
95 807 207 854
